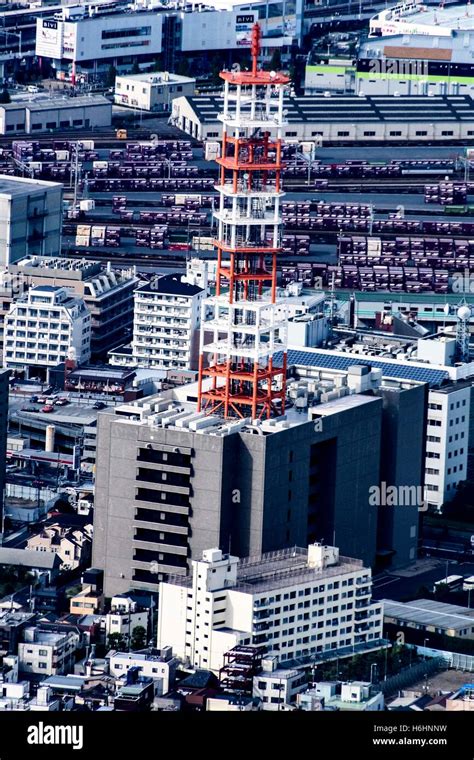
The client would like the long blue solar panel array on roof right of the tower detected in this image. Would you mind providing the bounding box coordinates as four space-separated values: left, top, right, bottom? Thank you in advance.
274 349 449 386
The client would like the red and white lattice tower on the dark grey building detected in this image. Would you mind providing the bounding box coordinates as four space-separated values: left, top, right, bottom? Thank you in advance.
198 24 290 419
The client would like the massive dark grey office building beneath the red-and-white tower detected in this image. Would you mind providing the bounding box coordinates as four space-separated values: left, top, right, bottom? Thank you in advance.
93 370 423 595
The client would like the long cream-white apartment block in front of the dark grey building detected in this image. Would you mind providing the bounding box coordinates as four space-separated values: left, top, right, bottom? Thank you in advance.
158 544 383 671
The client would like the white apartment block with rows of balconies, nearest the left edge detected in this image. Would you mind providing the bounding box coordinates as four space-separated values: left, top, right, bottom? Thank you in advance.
3 285 91 377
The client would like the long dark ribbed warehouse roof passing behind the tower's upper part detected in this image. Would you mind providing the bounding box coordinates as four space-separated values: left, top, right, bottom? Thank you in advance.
186 95 474 124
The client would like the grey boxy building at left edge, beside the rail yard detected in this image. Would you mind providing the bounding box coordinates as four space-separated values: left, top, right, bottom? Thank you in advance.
0 174 63 266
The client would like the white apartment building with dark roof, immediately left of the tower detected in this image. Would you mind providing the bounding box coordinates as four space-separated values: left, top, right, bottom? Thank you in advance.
132 274 205 369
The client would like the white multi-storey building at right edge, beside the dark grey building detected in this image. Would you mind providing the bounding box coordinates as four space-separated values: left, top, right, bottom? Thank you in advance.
425 382 471 510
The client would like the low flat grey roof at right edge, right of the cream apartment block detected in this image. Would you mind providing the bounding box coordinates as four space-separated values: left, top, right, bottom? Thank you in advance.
383 599 474 630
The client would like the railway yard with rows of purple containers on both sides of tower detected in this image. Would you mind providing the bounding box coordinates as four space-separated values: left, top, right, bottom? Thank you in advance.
0 128 474 293
